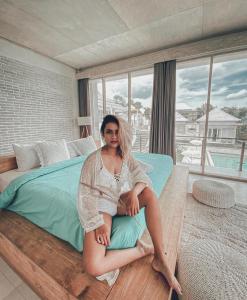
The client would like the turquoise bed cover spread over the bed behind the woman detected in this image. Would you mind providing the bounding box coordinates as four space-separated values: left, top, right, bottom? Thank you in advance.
0 152 173 252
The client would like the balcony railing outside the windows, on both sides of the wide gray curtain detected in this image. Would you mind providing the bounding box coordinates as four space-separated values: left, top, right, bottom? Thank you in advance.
132 130 247 172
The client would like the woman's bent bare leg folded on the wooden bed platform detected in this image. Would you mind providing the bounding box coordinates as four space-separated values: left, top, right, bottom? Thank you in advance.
83 213 153 276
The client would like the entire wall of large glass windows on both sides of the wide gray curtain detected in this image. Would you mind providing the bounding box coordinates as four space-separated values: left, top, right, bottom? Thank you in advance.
90 51 247 176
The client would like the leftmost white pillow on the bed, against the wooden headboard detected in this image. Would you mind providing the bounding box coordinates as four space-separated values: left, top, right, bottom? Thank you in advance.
12 142 40 172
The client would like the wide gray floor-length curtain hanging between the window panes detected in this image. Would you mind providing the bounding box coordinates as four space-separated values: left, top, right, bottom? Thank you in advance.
149 60 176 163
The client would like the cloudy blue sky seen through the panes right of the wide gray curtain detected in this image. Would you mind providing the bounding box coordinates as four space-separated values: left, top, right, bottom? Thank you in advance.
177 58 247 108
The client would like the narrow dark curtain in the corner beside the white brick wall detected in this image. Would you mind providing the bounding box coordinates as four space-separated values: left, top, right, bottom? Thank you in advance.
78 78 92 137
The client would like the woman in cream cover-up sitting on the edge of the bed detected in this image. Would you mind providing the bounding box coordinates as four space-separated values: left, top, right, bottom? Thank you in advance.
77 115 182 294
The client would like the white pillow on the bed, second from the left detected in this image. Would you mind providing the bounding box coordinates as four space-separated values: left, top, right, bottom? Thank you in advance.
35 139 70 167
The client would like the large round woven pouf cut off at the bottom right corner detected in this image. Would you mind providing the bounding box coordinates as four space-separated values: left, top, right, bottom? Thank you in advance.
178 239 247 300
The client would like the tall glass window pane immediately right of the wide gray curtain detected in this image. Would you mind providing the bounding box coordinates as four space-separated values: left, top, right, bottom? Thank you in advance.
176 58 210 169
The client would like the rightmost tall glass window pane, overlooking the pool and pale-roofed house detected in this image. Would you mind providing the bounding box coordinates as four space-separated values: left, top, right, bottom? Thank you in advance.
205 52 247 175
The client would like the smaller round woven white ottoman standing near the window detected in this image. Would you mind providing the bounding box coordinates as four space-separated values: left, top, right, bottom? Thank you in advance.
192 180 235 208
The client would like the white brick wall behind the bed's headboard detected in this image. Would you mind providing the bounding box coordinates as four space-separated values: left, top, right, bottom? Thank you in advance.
0 56 77 155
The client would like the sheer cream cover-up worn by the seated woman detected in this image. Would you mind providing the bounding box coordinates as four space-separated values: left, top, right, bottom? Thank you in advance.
77 148 152 232
